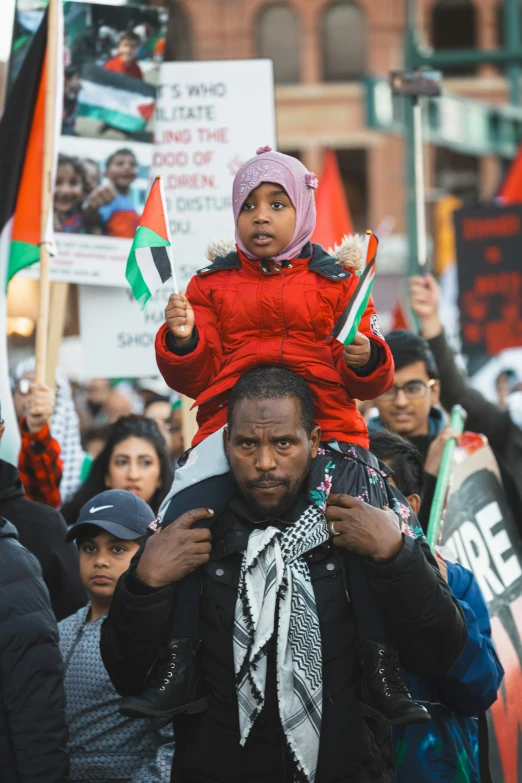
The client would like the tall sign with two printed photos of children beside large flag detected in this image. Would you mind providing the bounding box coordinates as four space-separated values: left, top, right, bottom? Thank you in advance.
11 0 162 286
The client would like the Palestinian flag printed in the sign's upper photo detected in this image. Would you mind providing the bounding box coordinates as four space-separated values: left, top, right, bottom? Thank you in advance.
78 65 156 133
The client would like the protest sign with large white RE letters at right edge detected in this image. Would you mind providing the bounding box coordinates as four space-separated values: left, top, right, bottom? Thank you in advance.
440 433 522 783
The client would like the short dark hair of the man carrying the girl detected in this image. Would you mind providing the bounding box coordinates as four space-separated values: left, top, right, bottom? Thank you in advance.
228 367 314 435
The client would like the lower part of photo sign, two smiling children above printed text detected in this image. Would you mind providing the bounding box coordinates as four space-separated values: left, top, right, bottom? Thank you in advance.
24 136 152 286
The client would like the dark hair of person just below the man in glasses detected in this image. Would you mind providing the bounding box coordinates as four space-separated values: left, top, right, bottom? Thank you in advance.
370 430 424 497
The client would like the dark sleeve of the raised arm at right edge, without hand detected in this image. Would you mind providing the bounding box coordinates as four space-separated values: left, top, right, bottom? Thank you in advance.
428 332 522 493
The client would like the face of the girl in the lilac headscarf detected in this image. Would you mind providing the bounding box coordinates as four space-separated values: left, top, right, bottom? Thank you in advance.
237 182 295 258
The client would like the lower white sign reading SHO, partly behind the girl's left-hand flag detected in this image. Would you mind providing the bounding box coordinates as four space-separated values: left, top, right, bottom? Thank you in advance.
79 284 173 378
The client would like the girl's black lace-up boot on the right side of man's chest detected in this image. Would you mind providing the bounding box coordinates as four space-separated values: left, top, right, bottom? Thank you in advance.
358 639 431 726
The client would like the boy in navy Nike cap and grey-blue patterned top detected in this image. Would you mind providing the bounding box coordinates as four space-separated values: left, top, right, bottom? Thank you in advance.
58 489 174 783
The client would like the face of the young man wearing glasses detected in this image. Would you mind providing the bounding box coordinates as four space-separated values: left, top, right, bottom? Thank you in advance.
375 361 439 438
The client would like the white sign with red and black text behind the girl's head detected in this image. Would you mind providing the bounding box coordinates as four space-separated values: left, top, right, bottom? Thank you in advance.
152 60 276 288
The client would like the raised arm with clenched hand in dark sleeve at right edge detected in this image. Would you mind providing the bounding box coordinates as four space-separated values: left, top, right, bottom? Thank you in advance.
410 275 522 493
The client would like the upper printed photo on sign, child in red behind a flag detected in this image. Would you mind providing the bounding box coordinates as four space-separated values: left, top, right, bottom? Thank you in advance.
10 2 167 142
